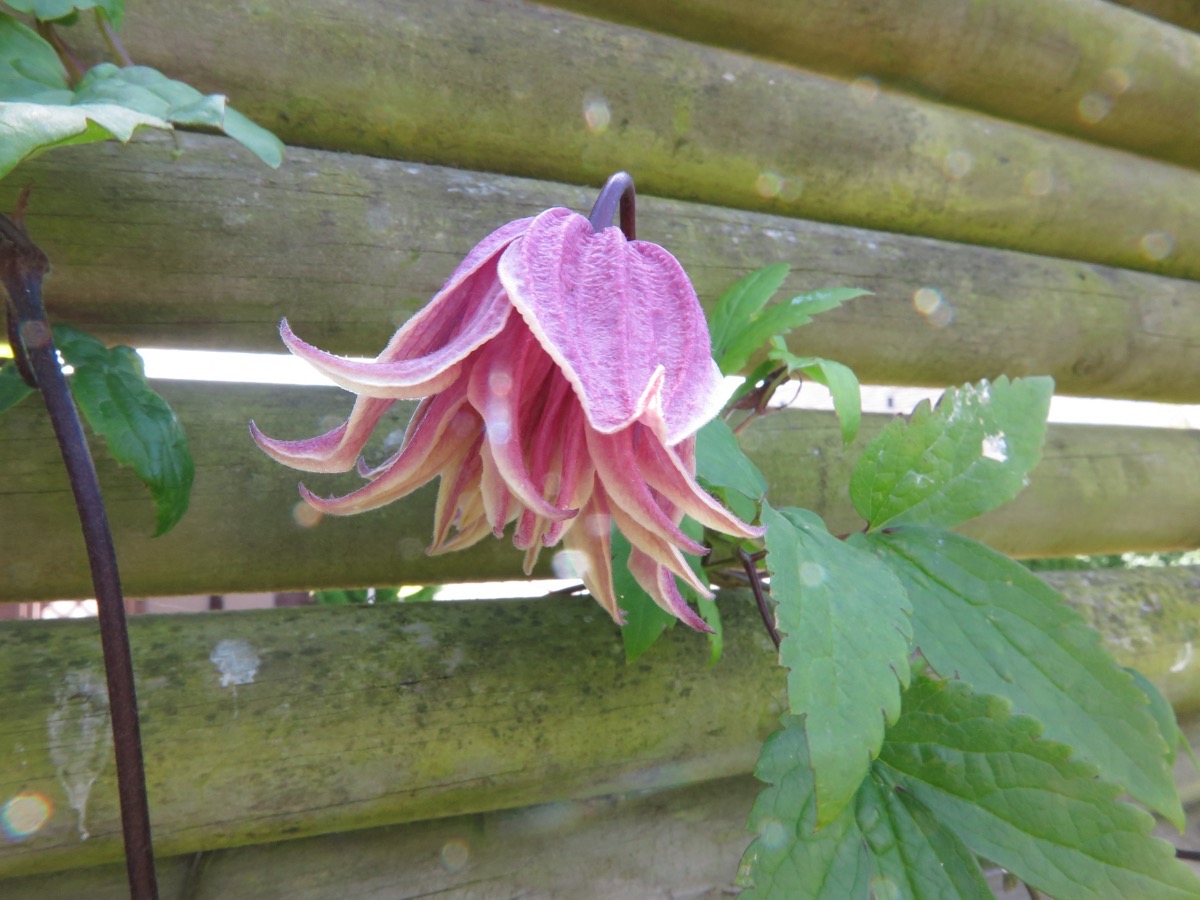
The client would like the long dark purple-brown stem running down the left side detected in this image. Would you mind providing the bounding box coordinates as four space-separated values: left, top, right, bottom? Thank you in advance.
0 194 158 900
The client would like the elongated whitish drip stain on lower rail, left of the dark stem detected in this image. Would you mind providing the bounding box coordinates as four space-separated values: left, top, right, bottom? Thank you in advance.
46 668 113 841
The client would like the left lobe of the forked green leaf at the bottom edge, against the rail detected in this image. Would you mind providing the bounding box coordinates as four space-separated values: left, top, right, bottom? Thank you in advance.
738 716 870 900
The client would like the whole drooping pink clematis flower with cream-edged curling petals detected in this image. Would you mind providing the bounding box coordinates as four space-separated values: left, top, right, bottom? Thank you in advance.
251 176 762 631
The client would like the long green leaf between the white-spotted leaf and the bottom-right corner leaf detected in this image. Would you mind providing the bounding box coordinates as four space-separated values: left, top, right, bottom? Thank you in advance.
866 529 1183 822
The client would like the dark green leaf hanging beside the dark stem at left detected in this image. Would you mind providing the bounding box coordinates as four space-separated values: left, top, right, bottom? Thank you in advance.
54 325 196 538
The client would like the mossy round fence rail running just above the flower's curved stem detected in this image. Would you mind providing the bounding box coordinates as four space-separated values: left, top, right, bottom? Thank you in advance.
56 0 1200 277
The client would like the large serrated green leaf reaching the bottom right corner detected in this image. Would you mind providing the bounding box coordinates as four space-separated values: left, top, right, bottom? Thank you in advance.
877 678 1200 900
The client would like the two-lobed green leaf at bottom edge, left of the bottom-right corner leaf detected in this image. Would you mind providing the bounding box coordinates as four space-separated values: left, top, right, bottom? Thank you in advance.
738 716 991 900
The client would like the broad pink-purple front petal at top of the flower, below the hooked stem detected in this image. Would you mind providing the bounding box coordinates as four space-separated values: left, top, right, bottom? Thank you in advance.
498 209 727 445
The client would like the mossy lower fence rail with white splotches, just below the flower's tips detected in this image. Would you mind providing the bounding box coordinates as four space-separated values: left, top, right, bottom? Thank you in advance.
0 569 1200 876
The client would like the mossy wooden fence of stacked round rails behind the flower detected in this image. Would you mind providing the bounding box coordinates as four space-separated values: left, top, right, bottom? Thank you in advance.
0 0 1200 898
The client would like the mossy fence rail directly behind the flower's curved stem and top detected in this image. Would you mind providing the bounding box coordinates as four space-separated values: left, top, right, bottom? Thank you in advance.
5 134 1200 402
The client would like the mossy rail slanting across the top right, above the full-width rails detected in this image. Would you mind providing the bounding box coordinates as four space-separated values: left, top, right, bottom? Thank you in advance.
550 0 1200 168
